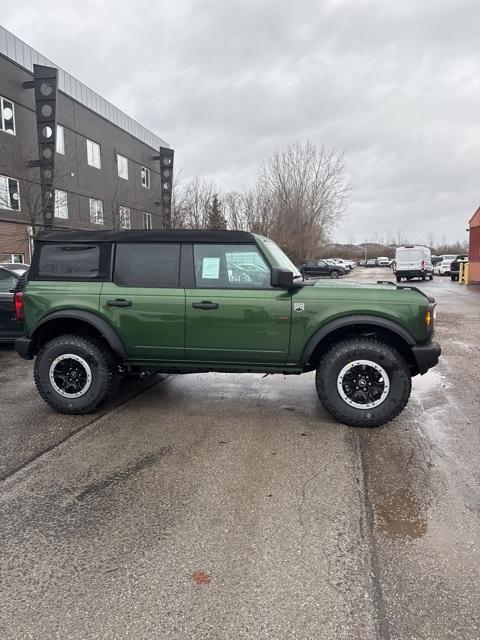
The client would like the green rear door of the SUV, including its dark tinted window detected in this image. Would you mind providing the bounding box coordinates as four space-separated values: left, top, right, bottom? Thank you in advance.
100 242 185 362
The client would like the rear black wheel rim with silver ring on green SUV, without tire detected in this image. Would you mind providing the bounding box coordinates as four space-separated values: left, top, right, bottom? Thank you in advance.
48 353 92 399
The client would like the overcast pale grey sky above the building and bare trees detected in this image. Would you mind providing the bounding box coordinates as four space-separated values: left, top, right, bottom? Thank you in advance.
0 0 480 242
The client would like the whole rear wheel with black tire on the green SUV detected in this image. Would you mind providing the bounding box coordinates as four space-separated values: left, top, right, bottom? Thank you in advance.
34 335 117 414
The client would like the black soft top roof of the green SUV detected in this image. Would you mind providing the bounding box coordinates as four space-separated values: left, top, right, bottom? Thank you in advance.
36 229 255 244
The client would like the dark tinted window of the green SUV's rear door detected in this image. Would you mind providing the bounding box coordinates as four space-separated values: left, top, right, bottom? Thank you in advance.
113 242 180 288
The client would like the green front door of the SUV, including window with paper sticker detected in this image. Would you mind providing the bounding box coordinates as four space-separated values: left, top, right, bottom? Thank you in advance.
185 244 292 364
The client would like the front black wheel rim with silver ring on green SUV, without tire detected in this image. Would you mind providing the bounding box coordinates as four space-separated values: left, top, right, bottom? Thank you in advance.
337 360 390 409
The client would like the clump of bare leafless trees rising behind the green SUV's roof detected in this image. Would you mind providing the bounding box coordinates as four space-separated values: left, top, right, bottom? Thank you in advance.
172 142 352 260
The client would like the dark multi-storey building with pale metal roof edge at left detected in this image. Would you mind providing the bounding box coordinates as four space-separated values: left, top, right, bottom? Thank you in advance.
0 26 173 262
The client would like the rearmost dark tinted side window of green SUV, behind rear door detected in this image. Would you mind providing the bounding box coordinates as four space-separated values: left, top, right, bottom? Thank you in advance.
38 244 100 279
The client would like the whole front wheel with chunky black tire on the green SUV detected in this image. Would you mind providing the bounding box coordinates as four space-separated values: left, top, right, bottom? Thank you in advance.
315 338 412 427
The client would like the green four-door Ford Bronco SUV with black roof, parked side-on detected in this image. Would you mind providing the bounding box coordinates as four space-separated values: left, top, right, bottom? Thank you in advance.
15 230 440 426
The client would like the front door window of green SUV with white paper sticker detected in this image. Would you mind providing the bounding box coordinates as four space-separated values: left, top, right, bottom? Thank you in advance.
193 244 270 289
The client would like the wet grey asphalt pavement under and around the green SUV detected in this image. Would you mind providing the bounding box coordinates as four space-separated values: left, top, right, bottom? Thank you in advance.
0 268 480 640
